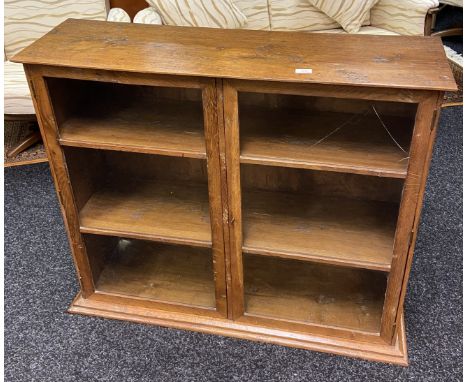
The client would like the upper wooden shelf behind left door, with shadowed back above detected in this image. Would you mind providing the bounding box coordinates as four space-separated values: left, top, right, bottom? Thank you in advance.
60 101 206 159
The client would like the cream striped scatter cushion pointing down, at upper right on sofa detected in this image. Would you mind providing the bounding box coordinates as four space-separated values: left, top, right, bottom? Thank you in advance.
309 0 378 33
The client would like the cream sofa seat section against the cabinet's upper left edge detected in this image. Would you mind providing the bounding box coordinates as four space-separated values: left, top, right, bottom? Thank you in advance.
3 61 34 114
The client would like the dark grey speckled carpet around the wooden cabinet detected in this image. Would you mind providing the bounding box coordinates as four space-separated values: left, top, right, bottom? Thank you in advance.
5 108 462 382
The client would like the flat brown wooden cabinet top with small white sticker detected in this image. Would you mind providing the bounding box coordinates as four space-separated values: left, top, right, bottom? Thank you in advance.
13 19 457 90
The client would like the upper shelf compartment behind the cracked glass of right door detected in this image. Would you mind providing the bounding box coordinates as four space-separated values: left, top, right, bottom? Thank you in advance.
240 107 414 178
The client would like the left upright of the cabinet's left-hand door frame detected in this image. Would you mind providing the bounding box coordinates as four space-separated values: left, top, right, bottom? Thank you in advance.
25 65 94 298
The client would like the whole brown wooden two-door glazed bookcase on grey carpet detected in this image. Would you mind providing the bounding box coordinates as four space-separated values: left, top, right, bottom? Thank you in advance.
15 20 456 364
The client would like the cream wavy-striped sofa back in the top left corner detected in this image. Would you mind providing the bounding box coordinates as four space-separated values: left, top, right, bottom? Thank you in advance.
4 0 106 59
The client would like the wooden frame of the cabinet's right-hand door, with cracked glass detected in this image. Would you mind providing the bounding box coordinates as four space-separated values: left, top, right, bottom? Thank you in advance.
223 79 442 344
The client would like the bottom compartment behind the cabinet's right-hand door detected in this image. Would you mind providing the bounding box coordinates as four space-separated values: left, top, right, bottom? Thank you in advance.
244 255 387 333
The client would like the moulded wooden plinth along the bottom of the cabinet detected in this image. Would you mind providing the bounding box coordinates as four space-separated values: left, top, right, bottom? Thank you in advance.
69 294 408 366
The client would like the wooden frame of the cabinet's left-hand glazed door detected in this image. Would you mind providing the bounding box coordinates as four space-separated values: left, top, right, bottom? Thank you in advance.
25 65 227 317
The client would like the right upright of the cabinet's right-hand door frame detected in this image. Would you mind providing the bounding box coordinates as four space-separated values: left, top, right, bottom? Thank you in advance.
381 93 439 342
